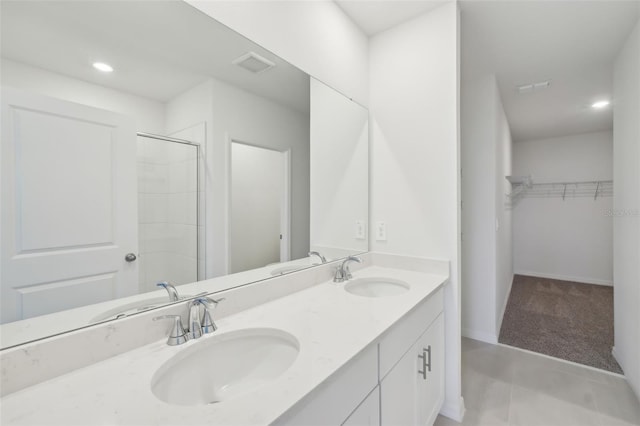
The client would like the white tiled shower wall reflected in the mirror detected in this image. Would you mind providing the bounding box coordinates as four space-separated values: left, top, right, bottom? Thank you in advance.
138 137 198 292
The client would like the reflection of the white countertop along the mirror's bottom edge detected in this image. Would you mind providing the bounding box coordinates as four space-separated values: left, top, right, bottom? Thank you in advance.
0 257 344 348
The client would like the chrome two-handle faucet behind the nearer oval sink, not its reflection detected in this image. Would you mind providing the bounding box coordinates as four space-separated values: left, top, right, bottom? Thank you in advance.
153 297 224 346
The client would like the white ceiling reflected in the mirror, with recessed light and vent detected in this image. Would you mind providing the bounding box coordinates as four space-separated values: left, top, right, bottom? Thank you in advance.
0 0 309 113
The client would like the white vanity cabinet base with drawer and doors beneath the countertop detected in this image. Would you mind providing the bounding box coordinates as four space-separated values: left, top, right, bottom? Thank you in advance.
275 280 444 426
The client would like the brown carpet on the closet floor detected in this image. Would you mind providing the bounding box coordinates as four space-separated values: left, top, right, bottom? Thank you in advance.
499 275 622 373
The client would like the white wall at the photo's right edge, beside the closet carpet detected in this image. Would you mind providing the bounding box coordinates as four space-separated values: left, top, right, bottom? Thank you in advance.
613 22 640 399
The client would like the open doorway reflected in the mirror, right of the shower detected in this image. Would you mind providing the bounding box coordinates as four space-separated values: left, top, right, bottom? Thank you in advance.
229 141 289 273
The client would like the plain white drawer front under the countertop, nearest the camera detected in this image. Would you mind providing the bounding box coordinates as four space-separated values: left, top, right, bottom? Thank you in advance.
273 345 378 426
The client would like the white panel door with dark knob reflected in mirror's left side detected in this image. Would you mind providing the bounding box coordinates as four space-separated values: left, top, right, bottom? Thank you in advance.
0 88 138 323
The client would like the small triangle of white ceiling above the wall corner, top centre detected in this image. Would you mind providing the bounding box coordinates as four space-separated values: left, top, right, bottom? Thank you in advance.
334 0 452 37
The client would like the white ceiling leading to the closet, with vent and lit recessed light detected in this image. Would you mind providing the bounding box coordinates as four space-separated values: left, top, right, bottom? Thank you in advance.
461 0 640 141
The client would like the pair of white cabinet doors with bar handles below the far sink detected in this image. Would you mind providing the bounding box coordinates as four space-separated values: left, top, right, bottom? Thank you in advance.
380 314 444 426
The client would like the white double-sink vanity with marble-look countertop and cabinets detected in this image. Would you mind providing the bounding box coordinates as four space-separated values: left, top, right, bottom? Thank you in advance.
1 253 449 425
